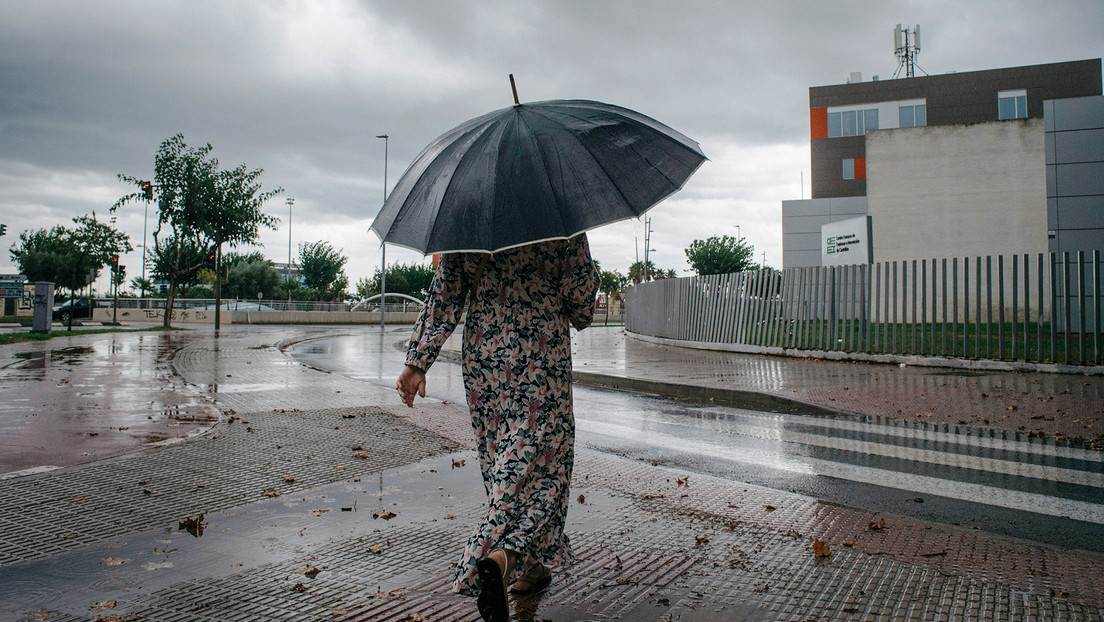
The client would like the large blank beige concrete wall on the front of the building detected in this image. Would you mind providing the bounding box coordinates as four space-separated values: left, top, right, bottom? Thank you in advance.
867 119 1047 262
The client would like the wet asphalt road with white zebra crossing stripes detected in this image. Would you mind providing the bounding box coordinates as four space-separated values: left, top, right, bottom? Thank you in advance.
286 333 1104 551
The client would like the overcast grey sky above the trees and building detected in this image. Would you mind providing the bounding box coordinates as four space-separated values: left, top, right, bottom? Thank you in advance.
0 0 1104 293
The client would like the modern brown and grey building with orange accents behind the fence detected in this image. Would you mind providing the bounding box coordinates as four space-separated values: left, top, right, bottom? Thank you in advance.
782 59 1104 267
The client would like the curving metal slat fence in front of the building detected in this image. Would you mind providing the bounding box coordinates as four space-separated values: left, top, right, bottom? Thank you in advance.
625 251 1102 365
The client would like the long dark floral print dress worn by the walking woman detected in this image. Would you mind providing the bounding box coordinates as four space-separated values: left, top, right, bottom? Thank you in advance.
406 234 598 595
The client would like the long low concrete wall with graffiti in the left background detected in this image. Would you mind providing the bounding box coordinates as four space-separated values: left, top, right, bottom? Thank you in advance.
92 308 420 325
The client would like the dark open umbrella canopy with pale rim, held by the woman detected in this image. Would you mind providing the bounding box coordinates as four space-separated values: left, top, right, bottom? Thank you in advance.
371 99 705 254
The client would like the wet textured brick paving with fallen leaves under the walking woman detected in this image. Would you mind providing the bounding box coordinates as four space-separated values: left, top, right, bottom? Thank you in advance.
0 329 1104 622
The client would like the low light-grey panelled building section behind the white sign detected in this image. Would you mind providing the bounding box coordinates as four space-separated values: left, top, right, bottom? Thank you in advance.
782 197 877 267
